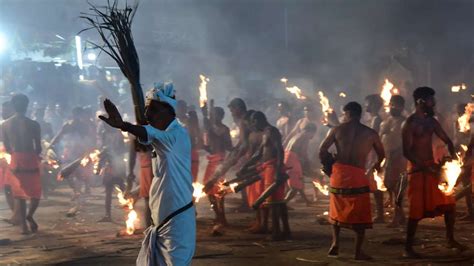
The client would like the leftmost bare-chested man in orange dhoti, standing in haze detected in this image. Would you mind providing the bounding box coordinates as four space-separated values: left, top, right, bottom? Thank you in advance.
2 94 41 234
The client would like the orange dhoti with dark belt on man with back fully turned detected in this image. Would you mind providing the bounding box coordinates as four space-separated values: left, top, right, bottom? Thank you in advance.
329 163 372 228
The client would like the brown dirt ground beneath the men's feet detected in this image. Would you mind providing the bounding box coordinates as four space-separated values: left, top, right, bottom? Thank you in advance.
0 184 474 266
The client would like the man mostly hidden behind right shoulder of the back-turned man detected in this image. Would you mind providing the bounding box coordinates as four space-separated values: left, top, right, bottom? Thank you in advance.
365 94 385 223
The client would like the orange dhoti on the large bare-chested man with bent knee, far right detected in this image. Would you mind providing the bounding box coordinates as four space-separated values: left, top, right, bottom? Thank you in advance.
408 162 456 220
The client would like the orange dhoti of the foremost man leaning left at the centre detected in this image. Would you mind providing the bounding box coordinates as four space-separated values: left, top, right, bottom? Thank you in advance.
255 160 285 204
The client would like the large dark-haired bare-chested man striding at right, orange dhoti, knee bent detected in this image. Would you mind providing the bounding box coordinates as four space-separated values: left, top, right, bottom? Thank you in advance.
402 87 463 258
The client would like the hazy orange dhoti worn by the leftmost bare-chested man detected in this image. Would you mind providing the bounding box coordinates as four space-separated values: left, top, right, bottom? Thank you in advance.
10 152 41 199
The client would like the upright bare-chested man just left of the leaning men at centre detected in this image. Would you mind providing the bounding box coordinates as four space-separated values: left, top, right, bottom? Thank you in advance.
202 103 232 226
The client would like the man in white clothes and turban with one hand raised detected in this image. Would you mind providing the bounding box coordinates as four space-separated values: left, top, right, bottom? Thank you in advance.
99 83 196 266
